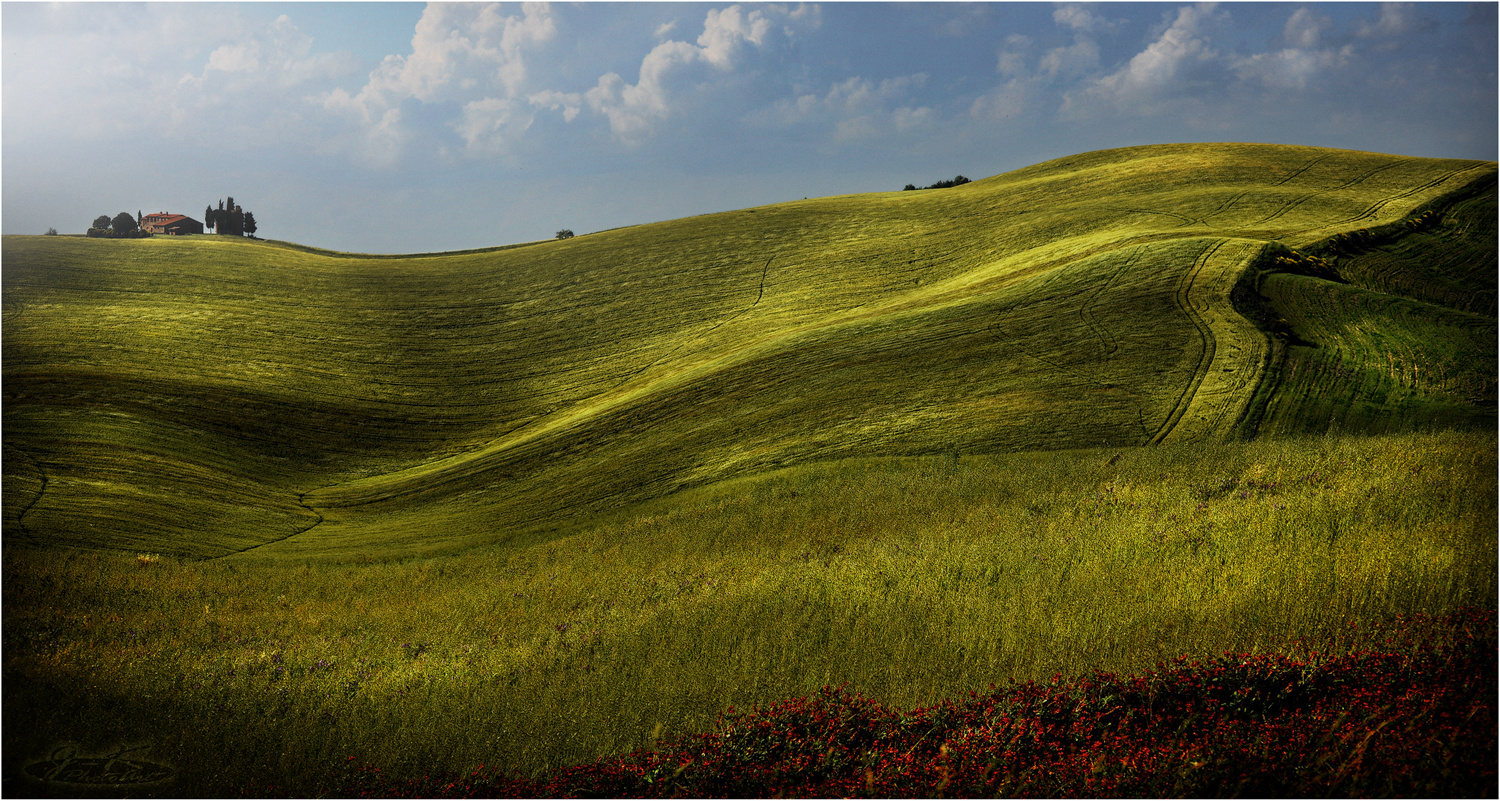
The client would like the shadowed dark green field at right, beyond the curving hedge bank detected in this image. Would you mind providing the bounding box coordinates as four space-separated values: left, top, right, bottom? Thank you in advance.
1241 177 1500 444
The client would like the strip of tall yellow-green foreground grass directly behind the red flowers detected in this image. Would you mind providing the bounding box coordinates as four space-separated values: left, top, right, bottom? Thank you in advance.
3 432 1497 797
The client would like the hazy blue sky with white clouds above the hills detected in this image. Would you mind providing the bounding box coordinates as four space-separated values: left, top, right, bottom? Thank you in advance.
0 2 1500 254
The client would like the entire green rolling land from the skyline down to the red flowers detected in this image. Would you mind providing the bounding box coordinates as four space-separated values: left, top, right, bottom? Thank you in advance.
3 144 1497 795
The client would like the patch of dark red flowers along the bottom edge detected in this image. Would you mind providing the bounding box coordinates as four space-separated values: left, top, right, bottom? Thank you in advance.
336 611 1497 798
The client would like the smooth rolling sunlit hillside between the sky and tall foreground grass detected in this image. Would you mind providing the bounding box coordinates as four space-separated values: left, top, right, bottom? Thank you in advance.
3 146 1496 557
